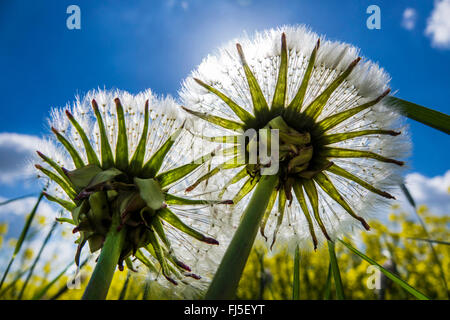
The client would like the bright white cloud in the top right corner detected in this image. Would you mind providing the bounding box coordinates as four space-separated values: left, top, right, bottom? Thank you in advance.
425 0 450 48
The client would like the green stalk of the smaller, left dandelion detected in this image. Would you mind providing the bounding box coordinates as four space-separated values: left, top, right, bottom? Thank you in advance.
82 214 125 300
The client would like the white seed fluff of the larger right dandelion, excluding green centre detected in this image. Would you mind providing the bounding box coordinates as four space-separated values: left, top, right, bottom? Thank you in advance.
179 26 410 252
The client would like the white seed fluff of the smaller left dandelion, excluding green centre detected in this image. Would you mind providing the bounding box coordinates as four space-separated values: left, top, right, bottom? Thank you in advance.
34 89 229 297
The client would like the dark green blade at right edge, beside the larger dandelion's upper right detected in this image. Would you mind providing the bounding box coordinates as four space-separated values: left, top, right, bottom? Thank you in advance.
385 96 450 134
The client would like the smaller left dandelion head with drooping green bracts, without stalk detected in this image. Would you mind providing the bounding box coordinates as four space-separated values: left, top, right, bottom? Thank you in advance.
36 91 230 284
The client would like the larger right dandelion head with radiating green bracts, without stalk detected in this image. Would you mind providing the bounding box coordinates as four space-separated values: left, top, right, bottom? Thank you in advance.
181 27 409 248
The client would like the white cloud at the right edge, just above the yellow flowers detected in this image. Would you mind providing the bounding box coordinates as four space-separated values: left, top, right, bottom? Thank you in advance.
402 170 450 215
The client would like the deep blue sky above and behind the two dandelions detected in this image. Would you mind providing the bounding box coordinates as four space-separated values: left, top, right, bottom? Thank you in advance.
0 0 450 198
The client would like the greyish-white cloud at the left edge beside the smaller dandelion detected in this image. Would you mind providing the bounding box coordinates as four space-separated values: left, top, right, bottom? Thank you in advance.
0 132 41 184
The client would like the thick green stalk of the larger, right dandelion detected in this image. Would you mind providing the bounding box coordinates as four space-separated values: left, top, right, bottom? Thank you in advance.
205 175 278 300
